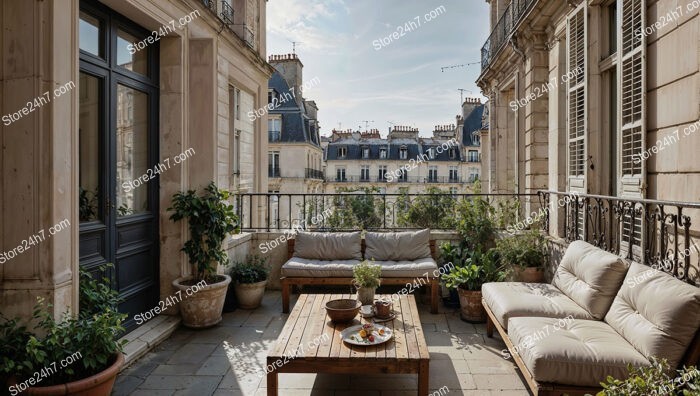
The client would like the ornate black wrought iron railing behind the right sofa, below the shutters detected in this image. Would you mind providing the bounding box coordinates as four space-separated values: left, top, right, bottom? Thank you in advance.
540 191 700 285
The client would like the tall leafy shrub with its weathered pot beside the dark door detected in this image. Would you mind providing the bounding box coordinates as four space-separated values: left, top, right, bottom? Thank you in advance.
168 182 239 328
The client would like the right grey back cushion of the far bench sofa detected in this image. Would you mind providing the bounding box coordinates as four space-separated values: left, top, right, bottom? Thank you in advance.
365 229 430 261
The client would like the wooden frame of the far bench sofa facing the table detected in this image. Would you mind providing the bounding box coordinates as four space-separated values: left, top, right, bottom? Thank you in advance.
280 239 440 314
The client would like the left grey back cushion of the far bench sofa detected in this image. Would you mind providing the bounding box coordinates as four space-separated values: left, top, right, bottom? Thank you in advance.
294 231 362 260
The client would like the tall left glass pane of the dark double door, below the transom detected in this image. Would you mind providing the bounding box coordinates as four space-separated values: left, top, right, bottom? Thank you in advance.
78 73 102 221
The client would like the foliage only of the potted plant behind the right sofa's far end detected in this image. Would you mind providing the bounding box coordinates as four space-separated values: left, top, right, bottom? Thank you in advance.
496 229 547 268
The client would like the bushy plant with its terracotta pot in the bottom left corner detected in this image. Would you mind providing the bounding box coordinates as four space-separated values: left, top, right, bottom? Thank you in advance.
0 264 126 396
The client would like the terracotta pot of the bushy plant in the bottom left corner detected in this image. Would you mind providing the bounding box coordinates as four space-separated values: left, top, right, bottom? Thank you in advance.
27 353 124 396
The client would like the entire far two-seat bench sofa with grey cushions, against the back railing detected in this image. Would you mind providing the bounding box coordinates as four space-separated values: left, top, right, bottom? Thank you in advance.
280 229 440 313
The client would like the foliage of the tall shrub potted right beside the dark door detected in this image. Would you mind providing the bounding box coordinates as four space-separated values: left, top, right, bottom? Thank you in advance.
168 182 240 283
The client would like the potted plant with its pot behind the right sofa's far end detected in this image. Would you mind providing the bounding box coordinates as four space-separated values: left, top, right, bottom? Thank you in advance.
496 229 547 283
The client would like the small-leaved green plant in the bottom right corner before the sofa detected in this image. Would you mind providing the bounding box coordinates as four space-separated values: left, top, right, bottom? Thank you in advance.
597 358 700 396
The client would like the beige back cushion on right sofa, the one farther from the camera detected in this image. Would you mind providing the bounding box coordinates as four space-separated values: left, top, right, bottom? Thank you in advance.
552 241 628 320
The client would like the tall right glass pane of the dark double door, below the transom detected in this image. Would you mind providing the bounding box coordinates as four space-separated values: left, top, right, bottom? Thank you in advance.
117 84 149 216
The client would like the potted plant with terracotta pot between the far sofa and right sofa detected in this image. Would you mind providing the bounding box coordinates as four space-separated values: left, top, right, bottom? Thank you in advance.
442 249 506 323
